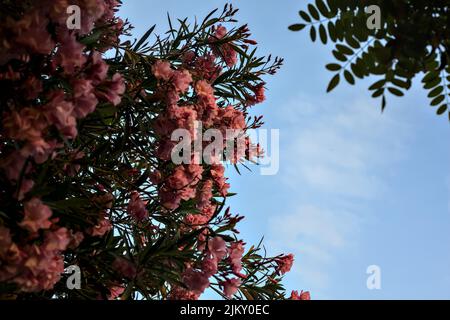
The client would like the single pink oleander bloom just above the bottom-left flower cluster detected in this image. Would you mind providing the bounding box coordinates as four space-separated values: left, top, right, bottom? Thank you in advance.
19 198 52 232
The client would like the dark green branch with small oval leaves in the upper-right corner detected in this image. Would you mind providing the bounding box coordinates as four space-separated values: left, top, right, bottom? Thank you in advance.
289 0 450 120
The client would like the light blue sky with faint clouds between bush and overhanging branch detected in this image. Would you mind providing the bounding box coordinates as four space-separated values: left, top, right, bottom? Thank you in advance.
121 0 450 299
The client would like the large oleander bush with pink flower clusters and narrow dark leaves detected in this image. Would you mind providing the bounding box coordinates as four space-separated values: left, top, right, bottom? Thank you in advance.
0 0 309 300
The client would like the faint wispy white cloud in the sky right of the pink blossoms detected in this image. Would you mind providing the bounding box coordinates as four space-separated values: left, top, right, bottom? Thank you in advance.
269 97 407 296
